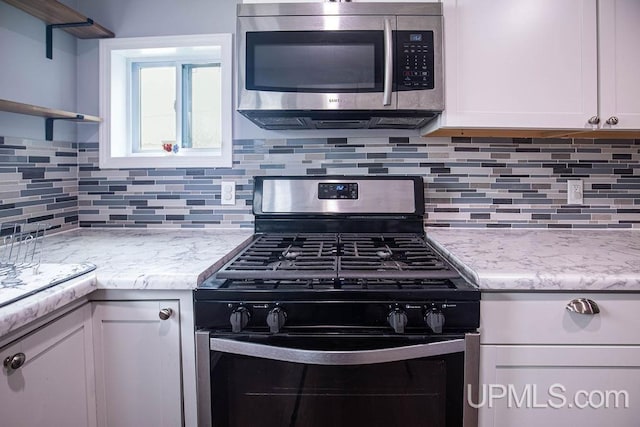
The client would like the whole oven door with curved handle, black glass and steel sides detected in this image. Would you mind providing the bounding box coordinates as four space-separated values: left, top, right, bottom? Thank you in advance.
196 331 480 427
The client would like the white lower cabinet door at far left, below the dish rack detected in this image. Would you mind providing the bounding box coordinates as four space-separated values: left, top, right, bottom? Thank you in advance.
0 304 96 427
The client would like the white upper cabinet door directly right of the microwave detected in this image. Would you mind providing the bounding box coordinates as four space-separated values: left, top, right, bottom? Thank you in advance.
441 0 600 129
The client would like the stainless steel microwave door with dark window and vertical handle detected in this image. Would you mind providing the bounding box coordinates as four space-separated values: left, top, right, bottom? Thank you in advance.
238 16 397 110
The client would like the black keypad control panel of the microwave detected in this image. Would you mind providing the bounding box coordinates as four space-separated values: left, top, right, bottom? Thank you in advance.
394 31 434 90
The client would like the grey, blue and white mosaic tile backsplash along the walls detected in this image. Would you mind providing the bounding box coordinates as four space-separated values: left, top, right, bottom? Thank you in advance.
0 137 640 228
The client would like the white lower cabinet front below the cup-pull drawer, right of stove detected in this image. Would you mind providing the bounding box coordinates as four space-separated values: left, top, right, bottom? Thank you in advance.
474 346 640 427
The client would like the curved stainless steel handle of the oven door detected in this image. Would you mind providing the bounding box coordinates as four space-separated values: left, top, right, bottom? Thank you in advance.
210 338 465 365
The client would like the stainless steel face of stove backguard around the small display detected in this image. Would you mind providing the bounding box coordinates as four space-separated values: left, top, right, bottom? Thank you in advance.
262 177 416 214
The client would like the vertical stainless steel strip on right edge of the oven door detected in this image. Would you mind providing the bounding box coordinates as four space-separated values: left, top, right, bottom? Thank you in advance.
462 333 480 427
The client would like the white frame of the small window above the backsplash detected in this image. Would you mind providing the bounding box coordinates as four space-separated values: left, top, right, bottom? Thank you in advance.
99 34 233 169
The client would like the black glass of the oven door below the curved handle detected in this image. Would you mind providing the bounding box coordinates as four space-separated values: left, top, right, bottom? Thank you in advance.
211 354 462 427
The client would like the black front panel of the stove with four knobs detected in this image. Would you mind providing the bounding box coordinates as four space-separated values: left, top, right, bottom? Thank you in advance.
195 300 480 335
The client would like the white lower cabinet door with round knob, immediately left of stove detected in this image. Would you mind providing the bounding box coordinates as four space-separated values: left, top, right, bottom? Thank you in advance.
93 301 182 427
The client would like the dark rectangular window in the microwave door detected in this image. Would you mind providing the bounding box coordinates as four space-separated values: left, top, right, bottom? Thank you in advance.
246 31 384 92
